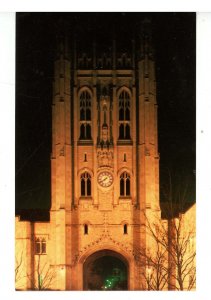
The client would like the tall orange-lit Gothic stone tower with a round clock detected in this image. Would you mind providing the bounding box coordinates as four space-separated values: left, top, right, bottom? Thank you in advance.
49 21 160 290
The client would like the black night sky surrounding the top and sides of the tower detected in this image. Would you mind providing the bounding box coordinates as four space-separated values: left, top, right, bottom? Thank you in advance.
16 13 196 208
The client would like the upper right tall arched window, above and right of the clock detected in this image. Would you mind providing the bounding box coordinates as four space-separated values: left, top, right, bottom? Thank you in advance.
119 90 130 140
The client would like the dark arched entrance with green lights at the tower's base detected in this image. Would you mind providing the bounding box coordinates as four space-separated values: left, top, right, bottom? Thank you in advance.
83 250 128 291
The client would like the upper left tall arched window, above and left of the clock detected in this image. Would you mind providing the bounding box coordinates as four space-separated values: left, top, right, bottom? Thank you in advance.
80 90 92 140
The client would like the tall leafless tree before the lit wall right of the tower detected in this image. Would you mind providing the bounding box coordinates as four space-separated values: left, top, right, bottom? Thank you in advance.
141 172 196 290
